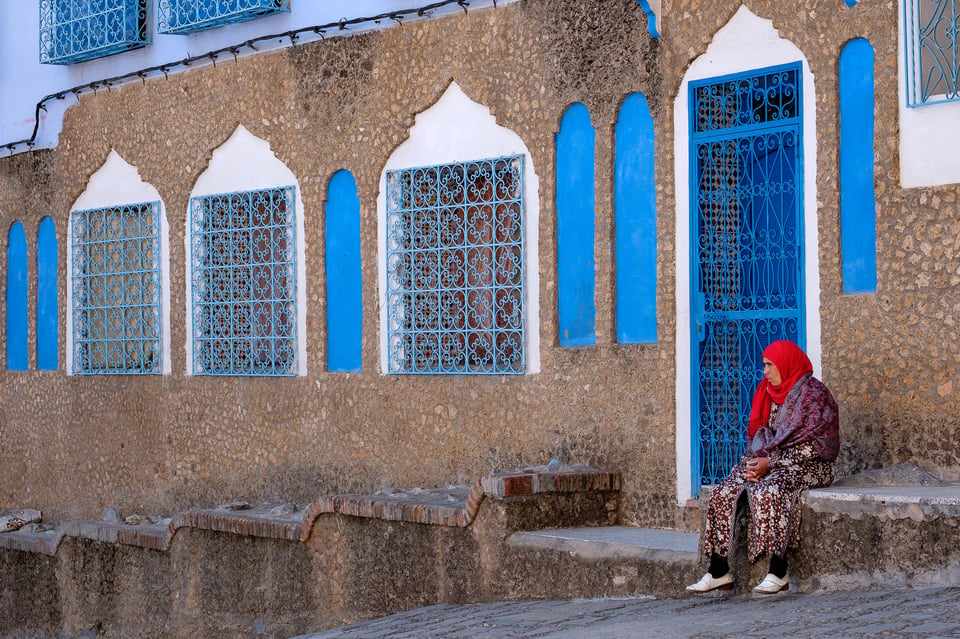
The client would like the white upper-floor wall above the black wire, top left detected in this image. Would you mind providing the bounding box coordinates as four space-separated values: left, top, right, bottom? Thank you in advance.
0 0 517 155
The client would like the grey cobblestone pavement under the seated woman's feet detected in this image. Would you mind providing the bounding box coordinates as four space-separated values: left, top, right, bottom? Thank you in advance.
290 587 960 639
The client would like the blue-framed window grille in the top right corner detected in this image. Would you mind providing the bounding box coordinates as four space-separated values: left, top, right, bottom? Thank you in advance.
903 0 960 107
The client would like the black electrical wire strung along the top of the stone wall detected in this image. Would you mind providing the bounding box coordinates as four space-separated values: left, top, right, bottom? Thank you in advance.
0 0 497 153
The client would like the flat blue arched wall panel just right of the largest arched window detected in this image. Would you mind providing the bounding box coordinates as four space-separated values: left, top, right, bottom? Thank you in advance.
556 102 597 346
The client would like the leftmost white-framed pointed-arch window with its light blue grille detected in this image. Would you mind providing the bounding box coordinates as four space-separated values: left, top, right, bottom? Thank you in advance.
66 151 170 375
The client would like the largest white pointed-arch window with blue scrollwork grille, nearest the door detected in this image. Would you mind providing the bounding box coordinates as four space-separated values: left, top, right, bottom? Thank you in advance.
377 83 540 375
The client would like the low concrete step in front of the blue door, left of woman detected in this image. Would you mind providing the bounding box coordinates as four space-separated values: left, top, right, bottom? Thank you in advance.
502 526 700 599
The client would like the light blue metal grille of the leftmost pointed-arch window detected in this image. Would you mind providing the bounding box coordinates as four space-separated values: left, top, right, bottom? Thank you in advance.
70 202 161 375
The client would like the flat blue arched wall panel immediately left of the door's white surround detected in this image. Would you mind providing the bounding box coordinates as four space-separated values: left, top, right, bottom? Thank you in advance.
613 93 657 344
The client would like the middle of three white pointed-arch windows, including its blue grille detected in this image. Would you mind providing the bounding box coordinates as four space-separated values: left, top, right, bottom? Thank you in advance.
187 126 306 376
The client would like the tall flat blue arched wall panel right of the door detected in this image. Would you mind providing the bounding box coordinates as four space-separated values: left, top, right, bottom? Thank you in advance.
839 38 877 293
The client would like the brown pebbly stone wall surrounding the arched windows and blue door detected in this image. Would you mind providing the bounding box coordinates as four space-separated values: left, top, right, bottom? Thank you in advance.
0 0 960 526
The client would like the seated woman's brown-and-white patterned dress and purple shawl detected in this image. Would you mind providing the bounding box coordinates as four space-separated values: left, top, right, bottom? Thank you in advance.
704 376 839 561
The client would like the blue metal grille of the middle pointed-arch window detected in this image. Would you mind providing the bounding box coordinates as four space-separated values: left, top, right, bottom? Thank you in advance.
190 186 297 376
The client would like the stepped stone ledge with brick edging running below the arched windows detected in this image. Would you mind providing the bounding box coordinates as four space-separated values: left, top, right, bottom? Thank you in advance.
0 465 620 639
